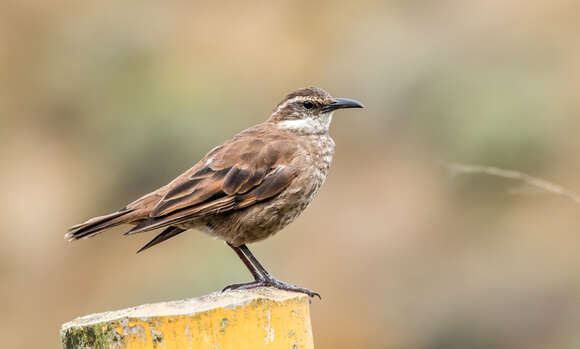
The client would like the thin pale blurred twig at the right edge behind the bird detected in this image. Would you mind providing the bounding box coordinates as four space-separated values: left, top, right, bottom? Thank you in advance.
443 163 580 204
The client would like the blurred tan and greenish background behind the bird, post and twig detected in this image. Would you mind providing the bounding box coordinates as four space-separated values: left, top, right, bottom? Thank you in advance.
0 0 580 349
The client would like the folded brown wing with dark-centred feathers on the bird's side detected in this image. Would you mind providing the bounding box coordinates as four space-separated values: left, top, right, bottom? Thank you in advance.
127 135 297 234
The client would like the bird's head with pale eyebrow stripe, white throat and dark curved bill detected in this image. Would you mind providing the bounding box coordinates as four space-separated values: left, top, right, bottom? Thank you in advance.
268 86 363 134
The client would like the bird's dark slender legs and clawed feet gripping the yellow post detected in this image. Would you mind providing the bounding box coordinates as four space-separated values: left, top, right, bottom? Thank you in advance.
223 243 321 298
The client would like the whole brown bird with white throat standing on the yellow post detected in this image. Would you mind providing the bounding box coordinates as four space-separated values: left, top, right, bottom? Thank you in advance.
65 86 363 297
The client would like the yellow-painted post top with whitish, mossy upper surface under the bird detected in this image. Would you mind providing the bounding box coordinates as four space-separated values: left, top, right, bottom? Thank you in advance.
61 288 314 349
